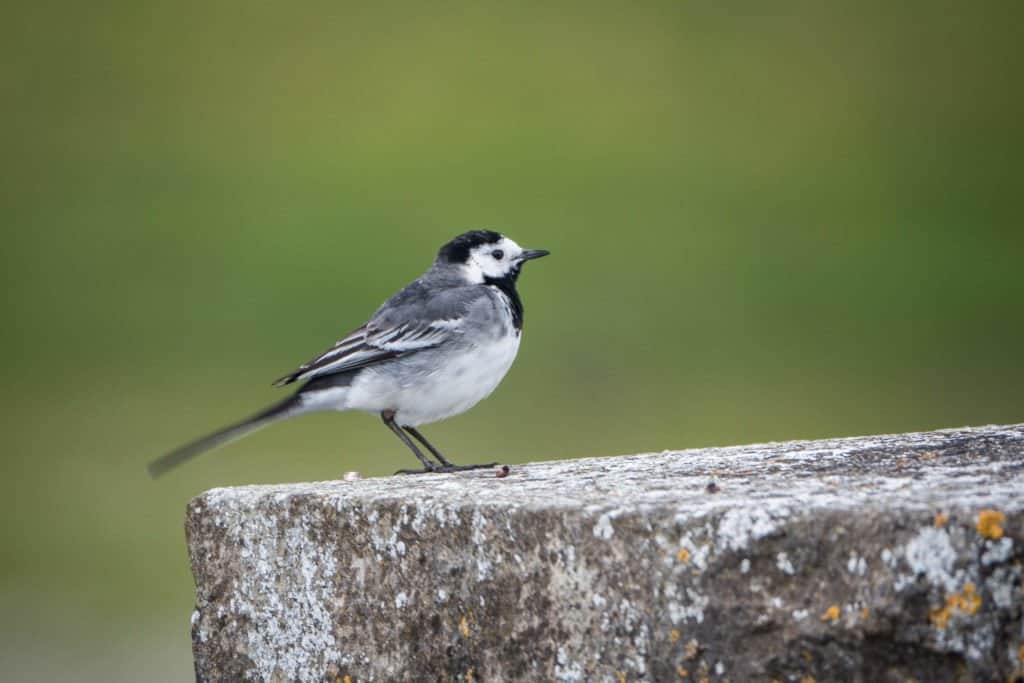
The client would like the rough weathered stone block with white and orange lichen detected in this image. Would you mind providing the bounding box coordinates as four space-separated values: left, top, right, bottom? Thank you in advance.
186 425 1024 682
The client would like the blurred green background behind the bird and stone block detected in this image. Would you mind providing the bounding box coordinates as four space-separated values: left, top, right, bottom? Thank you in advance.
0 1 1024 681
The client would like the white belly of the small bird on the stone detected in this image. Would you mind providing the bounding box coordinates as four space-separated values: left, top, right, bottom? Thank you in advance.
338 334 520 427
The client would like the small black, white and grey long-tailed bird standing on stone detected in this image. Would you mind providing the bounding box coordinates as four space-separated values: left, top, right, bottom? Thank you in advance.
148 229 550 477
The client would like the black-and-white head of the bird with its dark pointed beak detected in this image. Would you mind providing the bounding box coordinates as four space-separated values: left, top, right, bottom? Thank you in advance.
435 230 550 285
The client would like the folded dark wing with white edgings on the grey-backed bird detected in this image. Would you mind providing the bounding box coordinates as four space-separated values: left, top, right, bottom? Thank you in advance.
273 319 460 386
